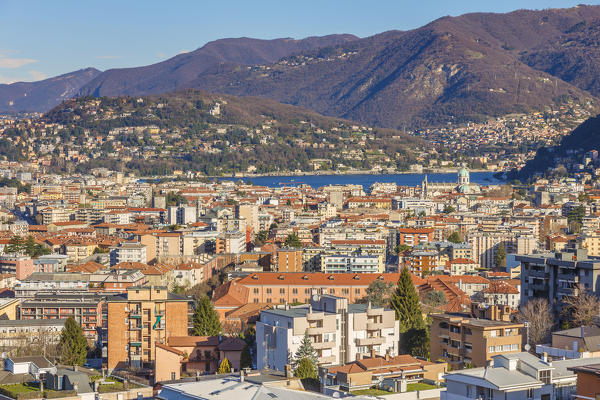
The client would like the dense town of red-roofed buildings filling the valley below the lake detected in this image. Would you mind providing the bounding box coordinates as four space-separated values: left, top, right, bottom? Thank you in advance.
0 163 600 400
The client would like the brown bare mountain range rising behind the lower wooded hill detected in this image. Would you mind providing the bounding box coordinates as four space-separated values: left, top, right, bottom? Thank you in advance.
0 5 600 129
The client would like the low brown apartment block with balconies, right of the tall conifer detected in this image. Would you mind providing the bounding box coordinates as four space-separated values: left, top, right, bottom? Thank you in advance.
430 314 523 369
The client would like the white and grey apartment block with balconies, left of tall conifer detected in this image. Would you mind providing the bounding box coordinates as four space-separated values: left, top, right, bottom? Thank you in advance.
256 294 399 371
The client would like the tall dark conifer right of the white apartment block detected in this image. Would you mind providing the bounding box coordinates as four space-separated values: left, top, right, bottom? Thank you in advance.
390 268 425 333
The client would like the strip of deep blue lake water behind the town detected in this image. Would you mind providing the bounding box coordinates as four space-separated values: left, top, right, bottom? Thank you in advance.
220 172 503 190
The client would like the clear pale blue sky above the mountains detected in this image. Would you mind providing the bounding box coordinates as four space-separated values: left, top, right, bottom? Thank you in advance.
0 0 599 83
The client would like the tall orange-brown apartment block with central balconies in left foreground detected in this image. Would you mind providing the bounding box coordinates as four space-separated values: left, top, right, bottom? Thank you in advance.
103 286 190 371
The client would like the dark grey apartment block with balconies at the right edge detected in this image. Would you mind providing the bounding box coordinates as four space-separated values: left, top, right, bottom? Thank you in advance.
515 248 600 312
